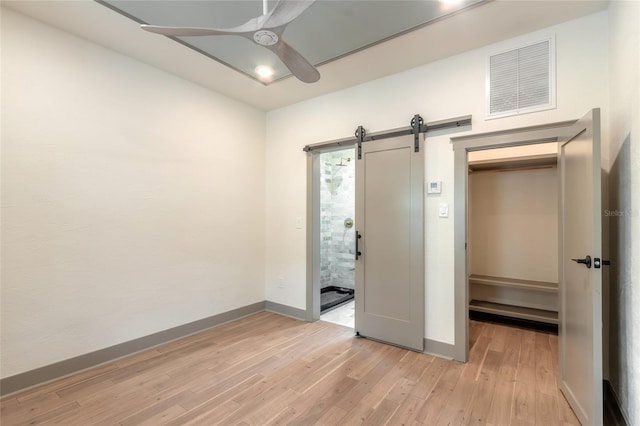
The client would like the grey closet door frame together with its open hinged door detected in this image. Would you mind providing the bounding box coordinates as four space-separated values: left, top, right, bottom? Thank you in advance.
451 109 608 425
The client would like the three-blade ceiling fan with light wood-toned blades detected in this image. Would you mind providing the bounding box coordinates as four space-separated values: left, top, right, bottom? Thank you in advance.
141 0 320 83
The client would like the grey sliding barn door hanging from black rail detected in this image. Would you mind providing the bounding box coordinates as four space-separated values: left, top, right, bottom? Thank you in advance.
355 136 424 351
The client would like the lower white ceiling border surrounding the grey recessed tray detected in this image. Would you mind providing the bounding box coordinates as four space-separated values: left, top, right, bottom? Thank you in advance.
2 0 608 110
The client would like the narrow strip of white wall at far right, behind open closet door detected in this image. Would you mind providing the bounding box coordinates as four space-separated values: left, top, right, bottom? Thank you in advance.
603 1 640 425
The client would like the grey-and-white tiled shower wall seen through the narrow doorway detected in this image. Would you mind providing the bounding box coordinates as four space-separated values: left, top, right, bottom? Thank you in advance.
320 149 356 288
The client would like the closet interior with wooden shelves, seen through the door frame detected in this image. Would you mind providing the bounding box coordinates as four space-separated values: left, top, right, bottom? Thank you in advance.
467 143 559 326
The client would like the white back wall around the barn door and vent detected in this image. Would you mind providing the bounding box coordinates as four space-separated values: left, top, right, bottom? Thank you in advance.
266 12 609 344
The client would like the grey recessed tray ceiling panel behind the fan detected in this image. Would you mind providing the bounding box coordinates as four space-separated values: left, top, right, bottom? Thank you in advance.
98 0 487 84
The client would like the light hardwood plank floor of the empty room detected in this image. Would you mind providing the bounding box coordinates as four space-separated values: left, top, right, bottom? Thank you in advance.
0 312 579 426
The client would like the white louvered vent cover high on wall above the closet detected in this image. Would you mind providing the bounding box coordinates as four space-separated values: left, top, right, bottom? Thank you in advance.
487 38 555 118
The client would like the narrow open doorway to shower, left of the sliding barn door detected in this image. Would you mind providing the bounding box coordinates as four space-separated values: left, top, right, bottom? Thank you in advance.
316 148 356 328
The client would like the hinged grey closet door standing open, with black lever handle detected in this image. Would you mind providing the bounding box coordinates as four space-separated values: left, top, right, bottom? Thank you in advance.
559 109 602 425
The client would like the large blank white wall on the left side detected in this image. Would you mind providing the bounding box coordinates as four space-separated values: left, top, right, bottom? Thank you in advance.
1 9 265 377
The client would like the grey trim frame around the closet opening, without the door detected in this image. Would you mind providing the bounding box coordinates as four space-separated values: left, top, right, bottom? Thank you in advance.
451 119 578 362
